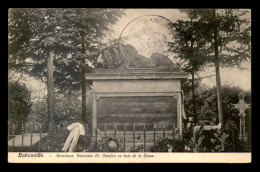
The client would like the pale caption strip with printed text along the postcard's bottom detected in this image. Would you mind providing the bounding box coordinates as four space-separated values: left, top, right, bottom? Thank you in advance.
8 152 251 163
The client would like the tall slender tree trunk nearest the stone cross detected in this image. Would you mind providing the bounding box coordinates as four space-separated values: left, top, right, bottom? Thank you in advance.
213 10 223 125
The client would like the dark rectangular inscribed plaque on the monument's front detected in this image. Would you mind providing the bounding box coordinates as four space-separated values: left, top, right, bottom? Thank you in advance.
97 96 177 131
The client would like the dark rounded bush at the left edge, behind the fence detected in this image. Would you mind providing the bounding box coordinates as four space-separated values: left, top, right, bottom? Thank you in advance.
8 82 32 134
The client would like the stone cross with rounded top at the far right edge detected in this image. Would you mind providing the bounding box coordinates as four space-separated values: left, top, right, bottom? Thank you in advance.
235 92 251 136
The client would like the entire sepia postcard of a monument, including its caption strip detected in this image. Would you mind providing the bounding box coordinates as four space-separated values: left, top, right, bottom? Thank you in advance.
7 8 252 163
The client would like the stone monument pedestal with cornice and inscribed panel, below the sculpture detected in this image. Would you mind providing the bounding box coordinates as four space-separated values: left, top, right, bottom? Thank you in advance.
87 69 187 152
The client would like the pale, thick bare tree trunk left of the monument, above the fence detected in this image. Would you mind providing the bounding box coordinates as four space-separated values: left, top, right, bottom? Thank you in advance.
47 51 55 128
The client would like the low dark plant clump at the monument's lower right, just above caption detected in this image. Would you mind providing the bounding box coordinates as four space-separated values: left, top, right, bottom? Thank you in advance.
150 138 185 152
